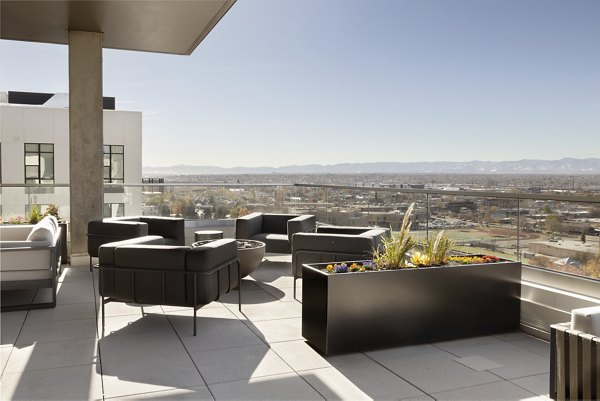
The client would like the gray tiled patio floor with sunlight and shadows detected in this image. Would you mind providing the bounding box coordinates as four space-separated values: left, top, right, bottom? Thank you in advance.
0 254 549 400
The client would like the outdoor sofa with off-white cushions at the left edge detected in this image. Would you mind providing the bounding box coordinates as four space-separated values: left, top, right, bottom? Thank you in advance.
0 216 64 311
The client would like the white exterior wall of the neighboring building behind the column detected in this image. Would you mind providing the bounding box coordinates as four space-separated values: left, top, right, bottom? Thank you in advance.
0 103 142 219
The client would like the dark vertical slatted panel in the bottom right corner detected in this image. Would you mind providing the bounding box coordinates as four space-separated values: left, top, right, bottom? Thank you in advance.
550 323 600 400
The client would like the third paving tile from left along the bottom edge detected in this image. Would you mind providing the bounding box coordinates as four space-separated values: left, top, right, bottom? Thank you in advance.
208 373 323 400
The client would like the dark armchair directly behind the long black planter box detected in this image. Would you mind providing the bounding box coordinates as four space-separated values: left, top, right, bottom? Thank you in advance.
292 226 390 298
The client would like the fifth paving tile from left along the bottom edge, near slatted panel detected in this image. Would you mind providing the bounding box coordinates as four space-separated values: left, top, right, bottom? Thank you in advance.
432 381 541 401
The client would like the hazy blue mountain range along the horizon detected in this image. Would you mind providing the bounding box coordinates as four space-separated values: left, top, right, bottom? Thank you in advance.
142 158 600 177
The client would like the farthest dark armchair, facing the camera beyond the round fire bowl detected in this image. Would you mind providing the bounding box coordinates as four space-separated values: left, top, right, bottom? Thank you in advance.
235 213 316 253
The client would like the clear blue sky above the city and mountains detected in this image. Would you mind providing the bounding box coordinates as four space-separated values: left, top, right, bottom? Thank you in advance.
0 0 600 167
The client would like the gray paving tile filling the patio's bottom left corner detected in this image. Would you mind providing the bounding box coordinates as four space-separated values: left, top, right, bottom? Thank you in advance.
0 365 102 401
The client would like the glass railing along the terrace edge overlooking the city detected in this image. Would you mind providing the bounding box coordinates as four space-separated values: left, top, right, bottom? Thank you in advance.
0 183 600 280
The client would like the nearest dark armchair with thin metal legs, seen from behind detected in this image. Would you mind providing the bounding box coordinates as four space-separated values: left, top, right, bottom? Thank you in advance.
98 236 242 335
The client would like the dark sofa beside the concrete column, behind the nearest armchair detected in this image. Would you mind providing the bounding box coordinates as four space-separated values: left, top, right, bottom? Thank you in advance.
88 216 185 270
